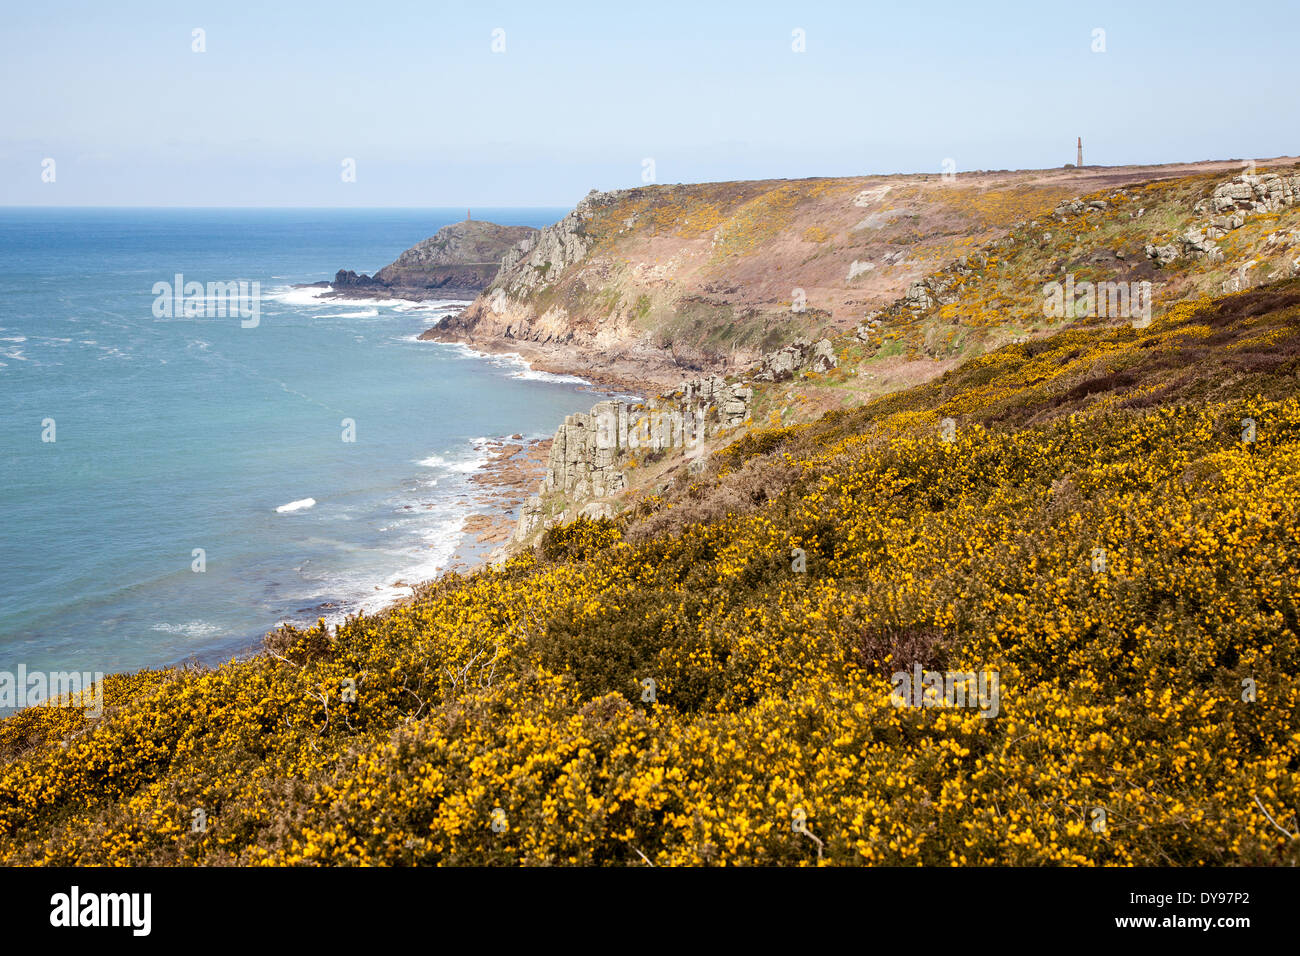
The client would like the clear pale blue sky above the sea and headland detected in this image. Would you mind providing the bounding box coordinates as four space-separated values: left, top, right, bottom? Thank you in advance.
0 0 1300 207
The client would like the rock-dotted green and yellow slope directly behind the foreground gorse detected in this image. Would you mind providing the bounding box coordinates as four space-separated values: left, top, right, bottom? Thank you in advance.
757 165 1300 423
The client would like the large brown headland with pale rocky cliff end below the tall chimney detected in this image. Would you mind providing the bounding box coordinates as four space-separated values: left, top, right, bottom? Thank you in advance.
423 163 1289 393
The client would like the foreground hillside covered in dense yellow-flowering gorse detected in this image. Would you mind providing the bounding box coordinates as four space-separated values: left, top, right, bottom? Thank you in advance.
0 280 1300 865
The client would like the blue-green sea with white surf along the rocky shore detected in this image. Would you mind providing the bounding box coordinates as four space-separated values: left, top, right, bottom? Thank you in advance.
0 208 599 672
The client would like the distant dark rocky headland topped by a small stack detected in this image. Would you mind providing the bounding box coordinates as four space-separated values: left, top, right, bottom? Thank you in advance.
332 220 537 299
